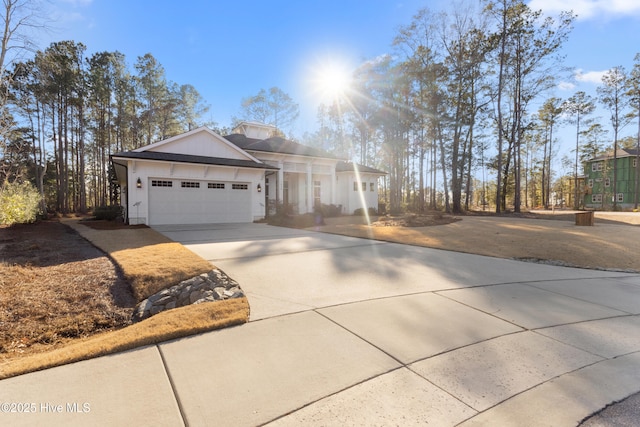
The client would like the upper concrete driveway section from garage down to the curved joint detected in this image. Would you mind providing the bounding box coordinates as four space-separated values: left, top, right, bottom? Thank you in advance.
154 224 625 320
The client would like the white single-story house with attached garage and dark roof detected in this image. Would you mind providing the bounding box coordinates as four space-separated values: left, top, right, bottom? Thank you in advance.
111 122 384 225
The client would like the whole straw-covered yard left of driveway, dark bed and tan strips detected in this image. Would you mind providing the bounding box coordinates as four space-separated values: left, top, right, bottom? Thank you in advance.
0 221 249 379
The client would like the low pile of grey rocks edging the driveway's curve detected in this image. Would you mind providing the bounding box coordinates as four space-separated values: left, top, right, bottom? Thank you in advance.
132 269 244 322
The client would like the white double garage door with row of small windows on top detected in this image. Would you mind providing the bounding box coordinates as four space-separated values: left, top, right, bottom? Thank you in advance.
149 178 253 225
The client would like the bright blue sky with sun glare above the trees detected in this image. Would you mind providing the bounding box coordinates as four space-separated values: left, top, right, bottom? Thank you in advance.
40 0 640 154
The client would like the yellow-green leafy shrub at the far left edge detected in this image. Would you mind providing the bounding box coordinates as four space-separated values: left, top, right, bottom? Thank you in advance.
0 181 40 225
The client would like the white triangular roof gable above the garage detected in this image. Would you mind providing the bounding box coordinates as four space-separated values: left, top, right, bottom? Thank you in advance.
133 126 262 163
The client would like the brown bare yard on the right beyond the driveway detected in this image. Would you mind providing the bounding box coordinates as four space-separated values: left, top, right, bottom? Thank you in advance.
316 211 640 272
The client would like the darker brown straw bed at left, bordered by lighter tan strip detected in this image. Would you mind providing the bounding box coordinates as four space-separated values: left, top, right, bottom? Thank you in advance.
0 221 135 363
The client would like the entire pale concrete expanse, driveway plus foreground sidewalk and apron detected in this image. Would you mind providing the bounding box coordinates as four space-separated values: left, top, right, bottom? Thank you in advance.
0 224 640 426
